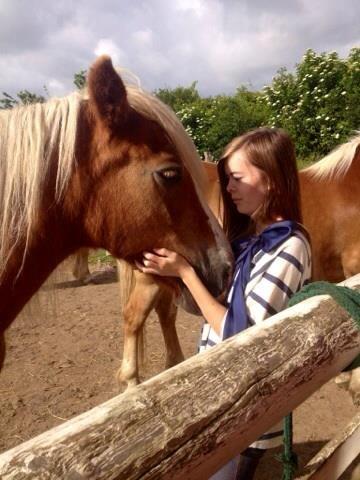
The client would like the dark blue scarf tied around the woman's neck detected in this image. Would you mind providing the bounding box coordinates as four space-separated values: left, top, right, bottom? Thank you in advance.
223 220 301 340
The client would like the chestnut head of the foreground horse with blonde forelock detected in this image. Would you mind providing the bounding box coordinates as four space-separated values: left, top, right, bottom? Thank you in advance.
66 57 232 310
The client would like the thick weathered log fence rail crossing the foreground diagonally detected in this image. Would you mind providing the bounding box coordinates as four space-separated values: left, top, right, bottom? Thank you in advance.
0 275 360 480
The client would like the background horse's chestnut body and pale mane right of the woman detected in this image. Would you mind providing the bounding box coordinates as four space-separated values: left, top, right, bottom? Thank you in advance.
300 135 360 282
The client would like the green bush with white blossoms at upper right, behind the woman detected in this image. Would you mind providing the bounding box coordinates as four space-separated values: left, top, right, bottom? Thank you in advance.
263 48 360 157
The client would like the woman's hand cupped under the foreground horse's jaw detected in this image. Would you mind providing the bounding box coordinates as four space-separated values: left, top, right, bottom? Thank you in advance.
136 248 192 278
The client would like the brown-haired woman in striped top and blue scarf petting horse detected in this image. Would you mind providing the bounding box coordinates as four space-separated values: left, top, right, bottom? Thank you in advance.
138 128 311 480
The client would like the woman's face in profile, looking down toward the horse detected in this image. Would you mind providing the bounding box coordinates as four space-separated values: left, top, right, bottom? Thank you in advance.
225 149 268 216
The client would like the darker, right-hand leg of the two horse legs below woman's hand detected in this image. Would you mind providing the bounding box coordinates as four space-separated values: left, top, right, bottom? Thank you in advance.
155 287 184 368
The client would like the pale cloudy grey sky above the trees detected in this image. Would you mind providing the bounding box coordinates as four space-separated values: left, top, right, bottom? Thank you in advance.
0 0 360 96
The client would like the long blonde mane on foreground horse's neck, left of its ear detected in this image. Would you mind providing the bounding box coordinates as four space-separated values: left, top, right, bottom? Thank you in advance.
0 93 81 276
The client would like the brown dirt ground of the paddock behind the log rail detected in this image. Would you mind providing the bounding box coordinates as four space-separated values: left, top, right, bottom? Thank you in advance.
0 265 360 480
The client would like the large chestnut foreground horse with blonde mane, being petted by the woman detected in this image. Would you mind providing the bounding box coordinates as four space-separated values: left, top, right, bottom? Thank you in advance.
0 56 232 368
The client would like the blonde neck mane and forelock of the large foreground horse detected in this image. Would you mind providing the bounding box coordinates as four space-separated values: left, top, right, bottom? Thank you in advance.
0 73 206 278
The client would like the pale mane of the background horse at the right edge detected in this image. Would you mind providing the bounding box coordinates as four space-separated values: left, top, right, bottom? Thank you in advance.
303 134 360 180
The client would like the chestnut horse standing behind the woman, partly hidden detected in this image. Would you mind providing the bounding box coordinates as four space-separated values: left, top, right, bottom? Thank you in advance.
74 135 360 385
